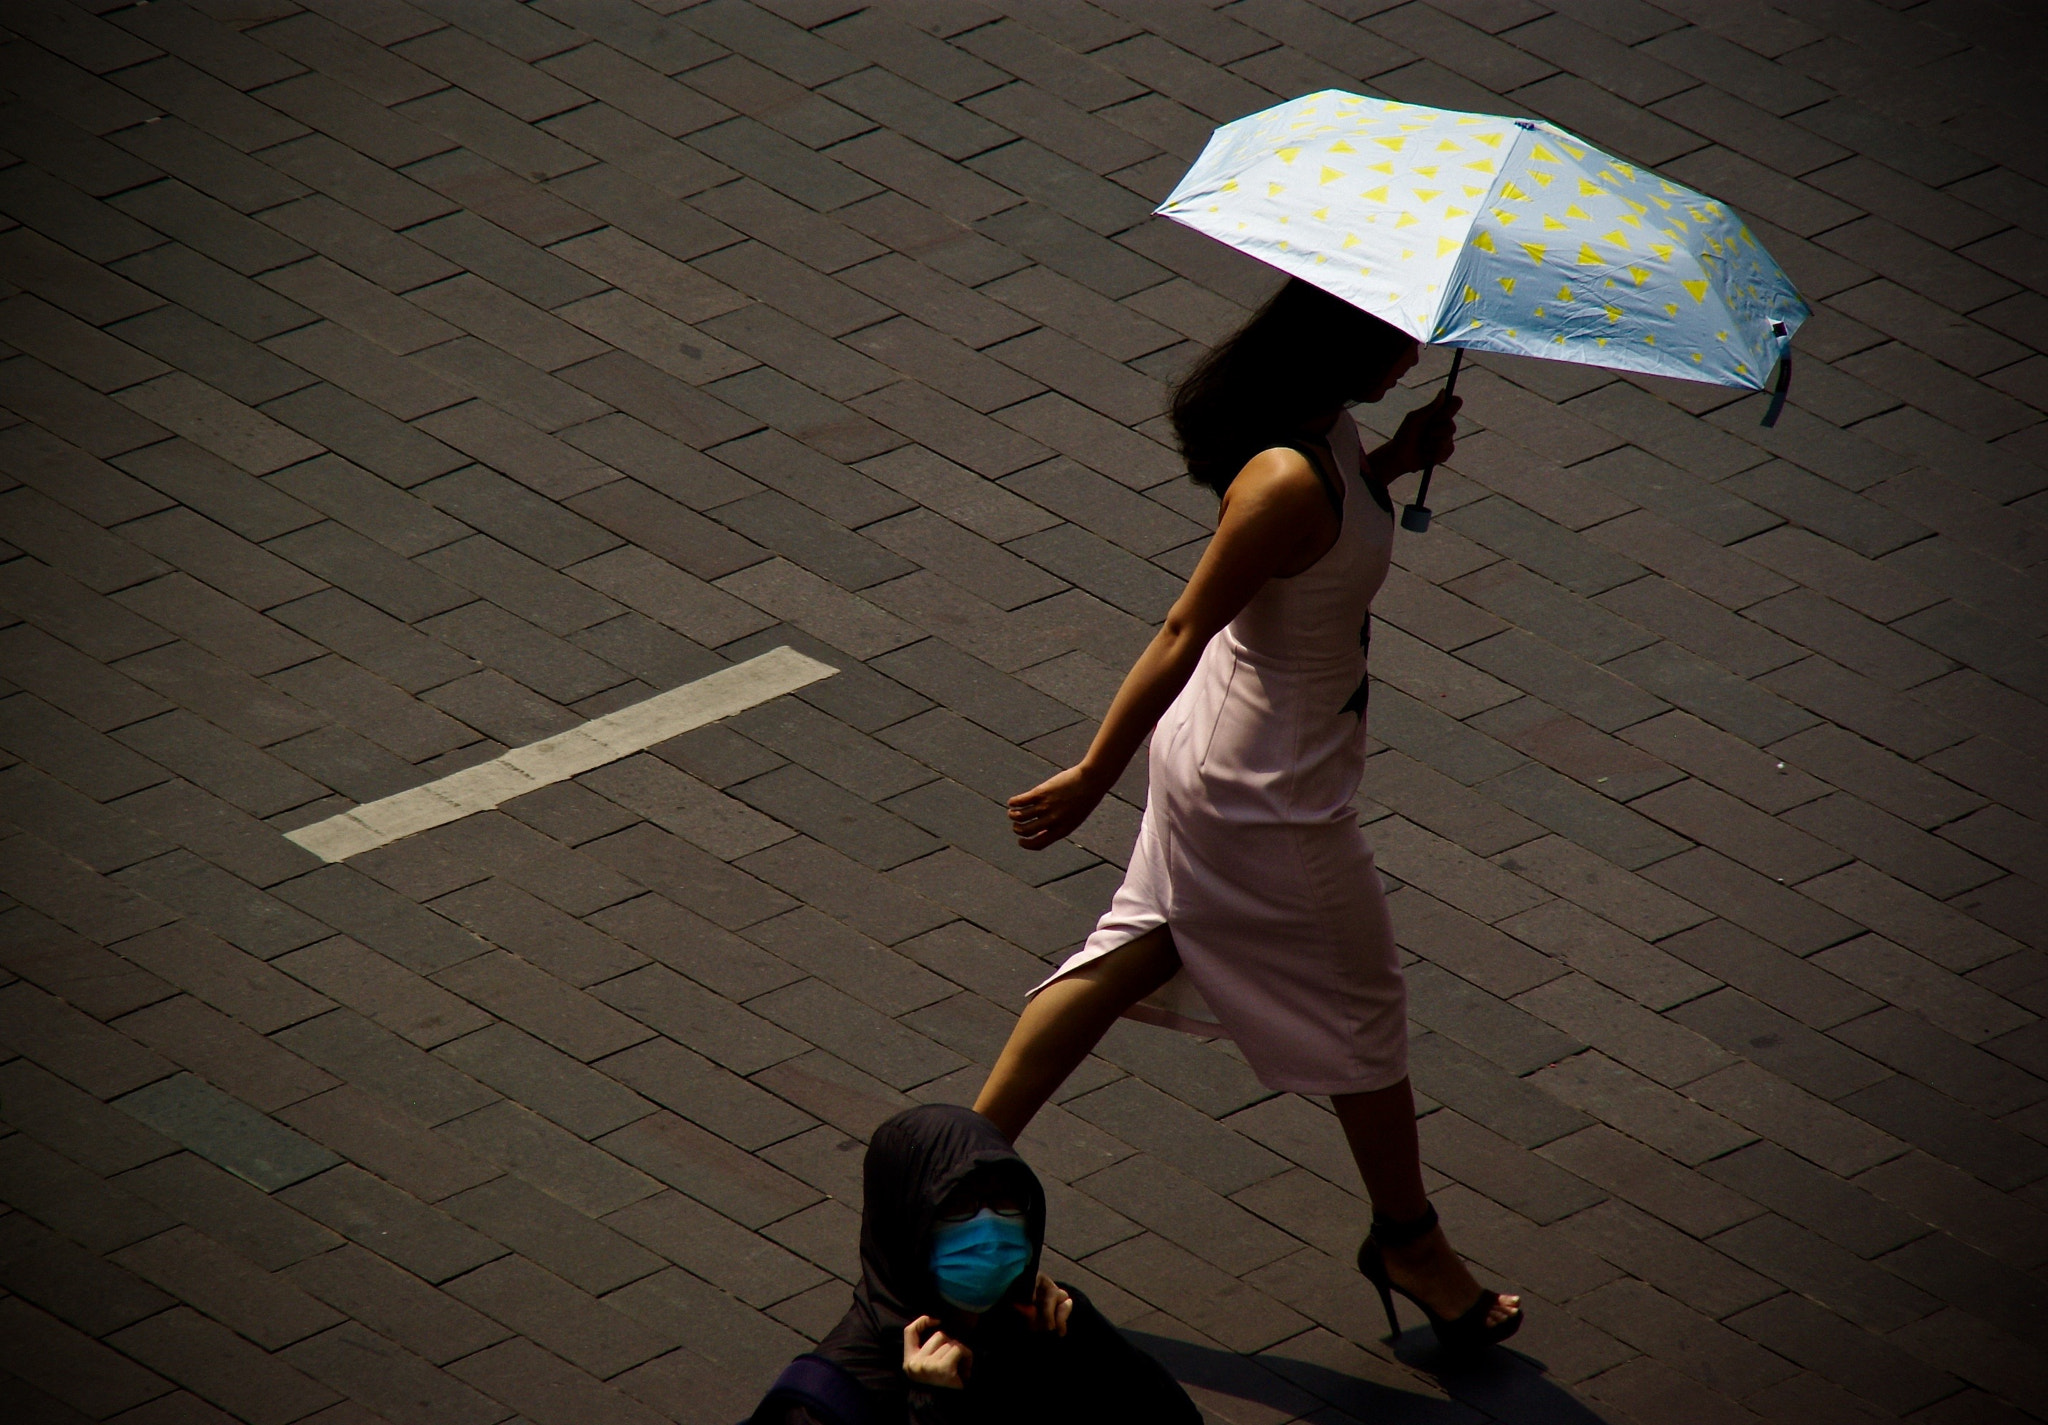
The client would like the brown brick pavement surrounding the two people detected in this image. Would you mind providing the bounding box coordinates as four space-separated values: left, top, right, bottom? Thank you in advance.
0 0 2048 1425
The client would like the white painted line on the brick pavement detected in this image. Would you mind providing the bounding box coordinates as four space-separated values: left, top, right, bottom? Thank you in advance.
285 647 840 862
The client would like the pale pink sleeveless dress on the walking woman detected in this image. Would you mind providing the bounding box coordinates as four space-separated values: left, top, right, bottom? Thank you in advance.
1032 414 1407 1093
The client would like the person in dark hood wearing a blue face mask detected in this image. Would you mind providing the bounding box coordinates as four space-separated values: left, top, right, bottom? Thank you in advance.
750 1104 1202 1425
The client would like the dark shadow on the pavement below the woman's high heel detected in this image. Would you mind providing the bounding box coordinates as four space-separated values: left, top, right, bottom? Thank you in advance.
1124 1327 1606 1425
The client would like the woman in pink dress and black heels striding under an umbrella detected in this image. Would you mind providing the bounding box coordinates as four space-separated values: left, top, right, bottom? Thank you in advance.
975 280 1522 1349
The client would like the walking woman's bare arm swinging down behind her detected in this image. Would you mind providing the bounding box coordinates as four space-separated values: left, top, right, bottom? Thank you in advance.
1010 448 1339 852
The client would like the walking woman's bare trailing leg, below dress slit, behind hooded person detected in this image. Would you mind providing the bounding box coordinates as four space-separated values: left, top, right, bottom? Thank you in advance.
975 925 1180 1142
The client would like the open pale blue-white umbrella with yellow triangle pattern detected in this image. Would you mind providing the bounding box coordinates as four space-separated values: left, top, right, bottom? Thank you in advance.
1157 90 1810 530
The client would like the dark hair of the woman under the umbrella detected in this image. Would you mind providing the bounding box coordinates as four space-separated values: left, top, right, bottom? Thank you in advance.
1169 276 1415 498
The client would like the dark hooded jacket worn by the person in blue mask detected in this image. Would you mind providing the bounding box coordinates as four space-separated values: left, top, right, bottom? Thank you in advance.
752 1104 1200 1425
